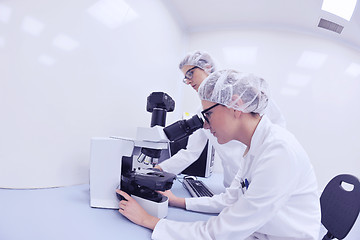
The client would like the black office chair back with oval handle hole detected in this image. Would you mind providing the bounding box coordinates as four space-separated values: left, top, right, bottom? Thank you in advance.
320 174 360 240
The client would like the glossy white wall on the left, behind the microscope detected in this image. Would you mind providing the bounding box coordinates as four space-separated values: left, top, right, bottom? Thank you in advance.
0 0 186 188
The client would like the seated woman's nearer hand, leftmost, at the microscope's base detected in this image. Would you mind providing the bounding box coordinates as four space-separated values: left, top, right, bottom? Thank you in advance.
116 189 160 230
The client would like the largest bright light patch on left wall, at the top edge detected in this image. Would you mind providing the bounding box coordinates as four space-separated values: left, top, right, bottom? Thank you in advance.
87 0 138 29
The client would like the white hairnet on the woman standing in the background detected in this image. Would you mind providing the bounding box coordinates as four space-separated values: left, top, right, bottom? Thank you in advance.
179 51 215 74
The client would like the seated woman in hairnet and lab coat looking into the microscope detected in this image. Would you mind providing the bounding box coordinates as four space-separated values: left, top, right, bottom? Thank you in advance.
119 70 320 240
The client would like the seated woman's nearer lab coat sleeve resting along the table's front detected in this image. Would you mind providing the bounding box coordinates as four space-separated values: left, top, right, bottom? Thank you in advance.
152 143 299 240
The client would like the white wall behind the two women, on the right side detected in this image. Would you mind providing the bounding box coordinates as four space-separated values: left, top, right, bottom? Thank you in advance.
184 29 360 189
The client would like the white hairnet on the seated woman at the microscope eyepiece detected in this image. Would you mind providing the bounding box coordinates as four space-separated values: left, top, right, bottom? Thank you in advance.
198 70 269 115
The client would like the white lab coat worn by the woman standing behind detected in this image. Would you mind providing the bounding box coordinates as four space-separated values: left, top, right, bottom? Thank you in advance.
159 100 285 187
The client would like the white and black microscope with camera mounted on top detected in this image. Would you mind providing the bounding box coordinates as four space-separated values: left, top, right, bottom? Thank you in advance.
90 92 203 218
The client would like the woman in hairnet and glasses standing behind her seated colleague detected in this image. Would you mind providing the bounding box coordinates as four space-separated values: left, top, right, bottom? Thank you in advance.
158 51 285 187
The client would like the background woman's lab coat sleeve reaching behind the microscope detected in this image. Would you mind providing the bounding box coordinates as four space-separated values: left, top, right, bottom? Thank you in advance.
159 129 208 174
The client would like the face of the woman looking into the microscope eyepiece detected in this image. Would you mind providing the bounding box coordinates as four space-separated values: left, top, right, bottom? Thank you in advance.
201 100 234 144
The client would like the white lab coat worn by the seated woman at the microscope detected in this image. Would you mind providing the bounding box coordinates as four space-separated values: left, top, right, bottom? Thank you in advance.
152 116 320 240
